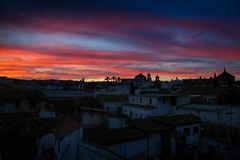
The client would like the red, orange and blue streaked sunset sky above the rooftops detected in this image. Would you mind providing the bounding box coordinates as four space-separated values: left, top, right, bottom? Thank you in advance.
0 0 240 80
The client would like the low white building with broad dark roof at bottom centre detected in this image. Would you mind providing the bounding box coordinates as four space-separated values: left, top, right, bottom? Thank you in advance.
84 128 159 159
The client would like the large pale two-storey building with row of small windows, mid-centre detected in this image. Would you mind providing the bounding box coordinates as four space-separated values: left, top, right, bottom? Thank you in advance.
122 94 190 118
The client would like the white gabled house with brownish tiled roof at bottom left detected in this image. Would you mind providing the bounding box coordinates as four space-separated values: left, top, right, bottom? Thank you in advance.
38 122 83 160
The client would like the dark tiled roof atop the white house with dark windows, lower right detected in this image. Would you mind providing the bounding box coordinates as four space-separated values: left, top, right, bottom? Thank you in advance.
152 114 201 127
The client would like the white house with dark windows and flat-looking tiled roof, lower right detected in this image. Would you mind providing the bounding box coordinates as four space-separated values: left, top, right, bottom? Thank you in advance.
151 114 201 157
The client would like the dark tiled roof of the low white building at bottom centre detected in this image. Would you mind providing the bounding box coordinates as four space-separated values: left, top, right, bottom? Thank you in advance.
84 128 147 146
